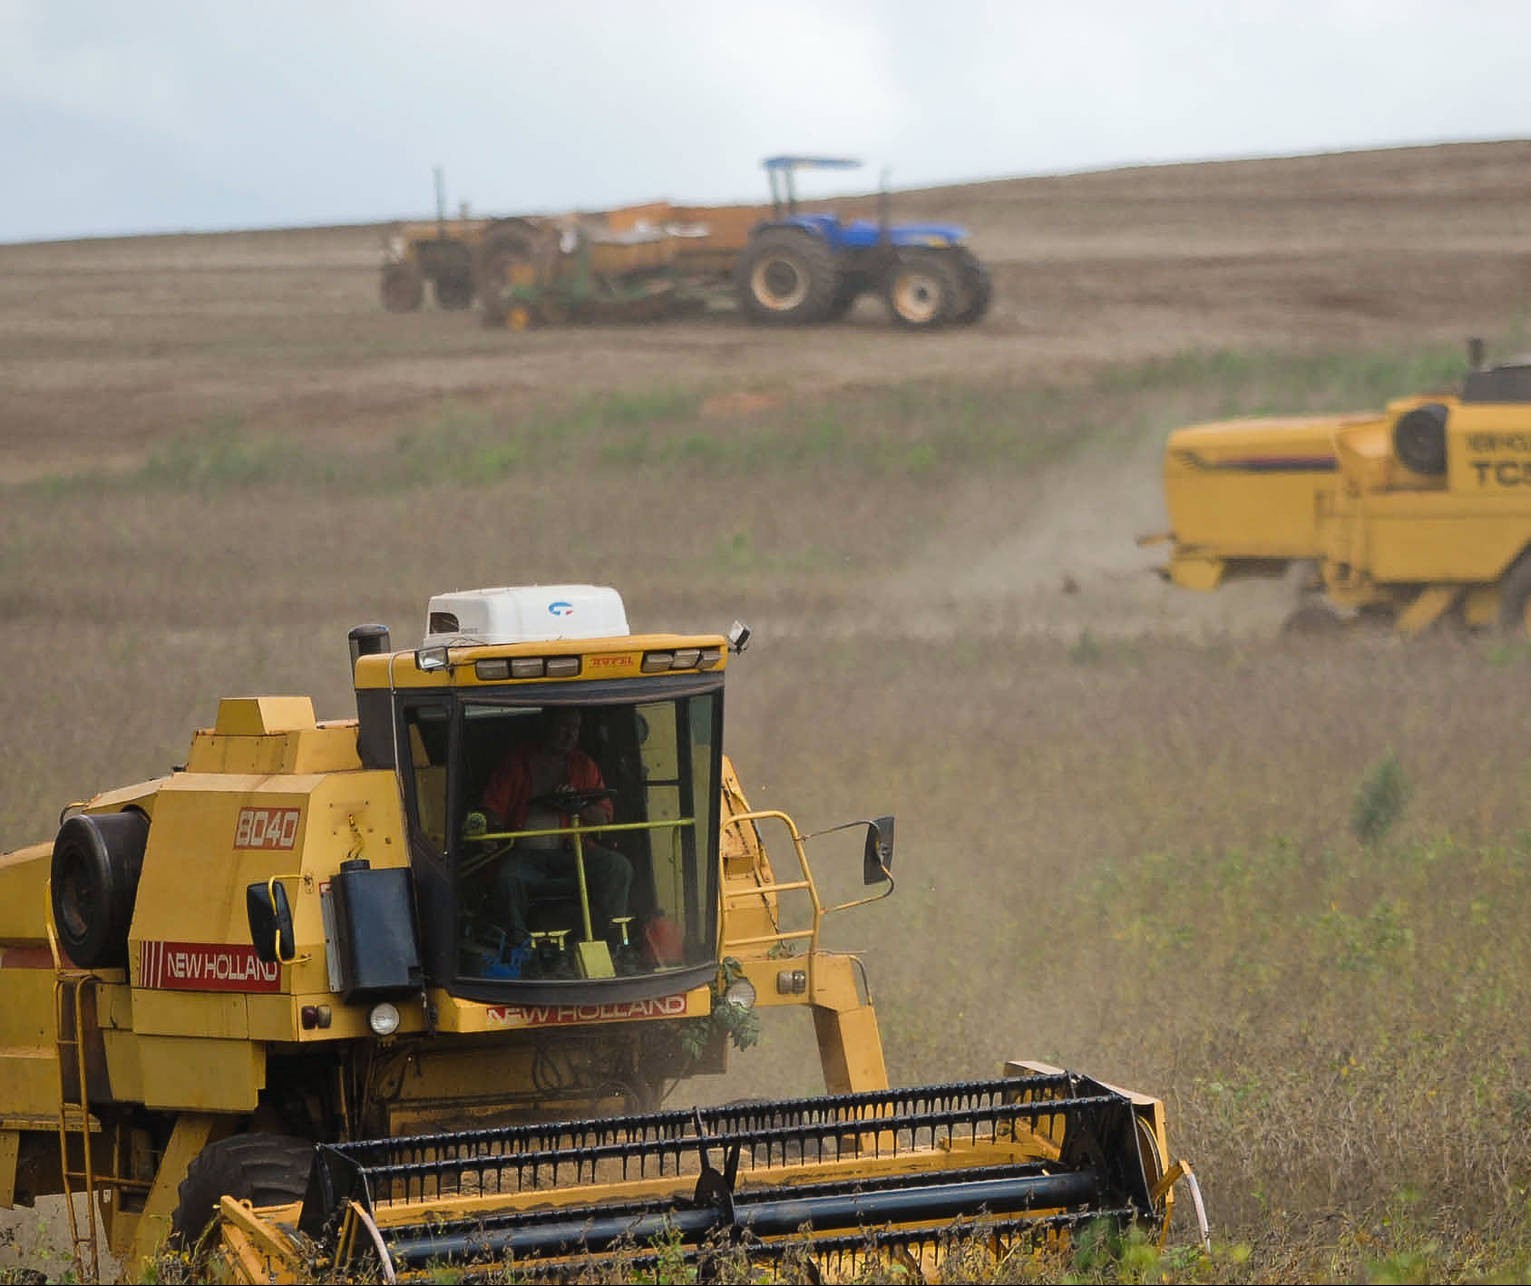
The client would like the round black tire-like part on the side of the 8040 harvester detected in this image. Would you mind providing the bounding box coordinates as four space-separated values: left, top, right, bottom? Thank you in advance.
49 810 149 969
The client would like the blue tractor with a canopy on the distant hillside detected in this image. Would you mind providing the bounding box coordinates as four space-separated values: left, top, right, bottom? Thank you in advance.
733 156 992 331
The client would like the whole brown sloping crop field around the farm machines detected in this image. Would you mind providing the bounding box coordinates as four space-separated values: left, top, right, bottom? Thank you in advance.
0 142 1531 1281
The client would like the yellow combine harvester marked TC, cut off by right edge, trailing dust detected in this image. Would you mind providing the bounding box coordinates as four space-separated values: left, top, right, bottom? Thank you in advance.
1144 344 1531 634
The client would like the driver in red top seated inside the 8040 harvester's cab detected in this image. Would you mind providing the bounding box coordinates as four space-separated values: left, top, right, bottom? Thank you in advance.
471 706 632 946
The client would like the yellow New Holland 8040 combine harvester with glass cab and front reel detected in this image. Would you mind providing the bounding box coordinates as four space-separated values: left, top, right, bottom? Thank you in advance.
0 585 1188 1281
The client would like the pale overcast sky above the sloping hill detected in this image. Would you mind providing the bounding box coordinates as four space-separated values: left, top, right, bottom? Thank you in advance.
0 0 1531 242
